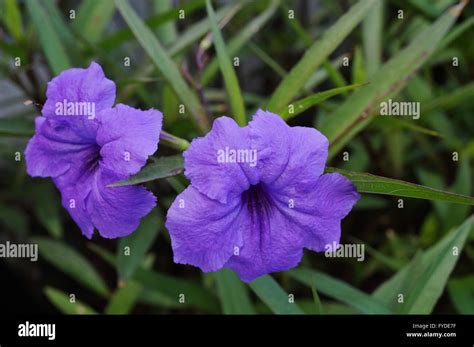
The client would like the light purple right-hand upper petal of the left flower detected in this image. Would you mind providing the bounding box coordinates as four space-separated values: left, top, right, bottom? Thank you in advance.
97 104 163 176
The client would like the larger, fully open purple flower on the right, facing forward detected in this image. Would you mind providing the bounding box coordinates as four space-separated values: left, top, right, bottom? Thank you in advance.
166 110 359 282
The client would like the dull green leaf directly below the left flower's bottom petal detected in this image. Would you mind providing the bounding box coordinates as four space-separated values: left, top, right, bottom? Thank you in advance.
116 209 163 281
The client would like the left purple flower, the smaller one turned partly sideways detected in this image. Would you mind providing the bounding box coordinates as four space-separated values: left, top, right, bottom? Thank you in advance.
25 63 163 238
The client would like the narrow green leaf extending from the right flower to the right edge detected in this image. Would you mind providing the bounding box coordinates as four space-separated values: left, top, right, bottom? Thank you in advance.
326 167 474 205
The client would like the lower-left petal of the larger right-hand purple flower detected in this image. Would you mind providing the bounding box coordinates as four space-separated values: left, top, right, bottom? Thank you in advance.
166 186 242 272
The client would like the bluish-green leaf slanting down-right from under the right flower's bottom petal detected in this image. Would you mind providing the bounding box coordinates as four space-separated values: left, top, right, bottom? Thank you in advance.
249 275 304 314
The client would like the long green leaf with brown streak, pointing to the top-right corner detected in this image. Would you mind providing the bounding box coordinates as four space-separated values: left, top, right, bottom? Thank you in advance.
320 2 462 158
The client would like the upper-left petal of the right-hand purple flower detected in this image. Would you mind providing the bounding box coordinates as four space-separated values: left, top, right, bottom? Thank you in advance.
183 117 256 203
